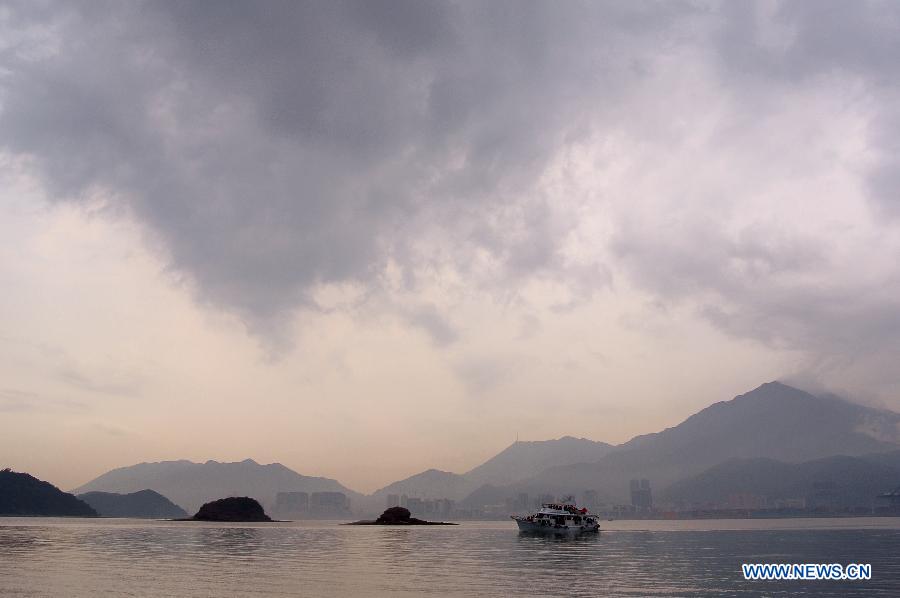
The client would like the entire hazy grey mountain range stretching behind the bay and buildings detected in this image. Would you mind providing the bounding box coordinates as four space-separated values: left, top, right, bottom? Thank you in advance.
67 382 900 513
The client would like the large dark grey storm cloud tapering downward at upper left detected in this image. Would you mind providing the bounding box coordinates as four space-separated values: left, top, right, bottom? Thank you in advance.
0 1 680 338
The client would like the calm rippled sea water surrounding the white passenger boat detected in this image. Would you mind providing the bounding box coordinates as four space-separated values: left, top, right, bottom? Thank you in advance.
0 518 900 597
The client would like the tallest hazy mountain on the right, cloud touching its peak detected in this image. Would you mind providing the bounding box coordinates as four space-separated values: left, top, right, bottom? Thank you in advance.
521 381 900 499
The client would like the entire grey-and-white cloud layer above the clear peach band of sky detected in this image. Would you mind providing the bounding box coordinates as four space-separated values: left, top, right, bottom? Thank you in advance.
0 0 900 488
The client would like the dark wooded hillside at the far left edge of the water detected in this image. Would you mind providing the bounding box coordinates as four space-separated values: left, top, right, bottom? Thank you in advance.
0 469 97 517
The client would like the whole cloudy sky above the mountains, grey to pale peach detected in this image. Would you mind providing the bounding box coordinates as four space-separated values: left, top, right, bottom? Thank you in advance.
0 0 900 492
